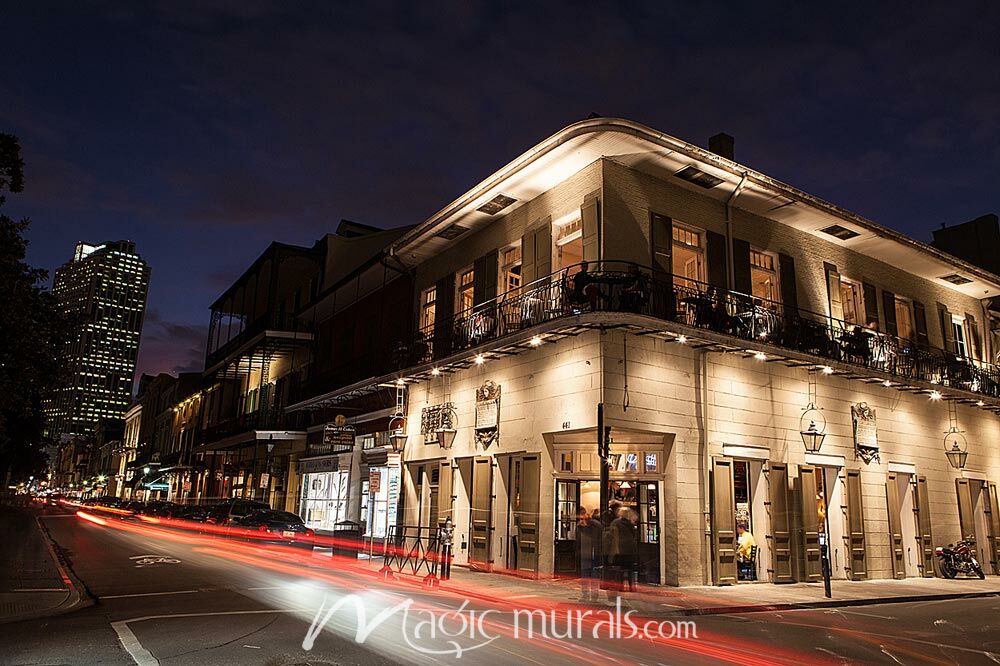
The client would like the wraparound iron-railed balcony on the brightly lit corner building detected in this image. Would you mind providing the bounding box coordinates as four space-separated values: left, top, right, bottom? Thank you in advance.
397 262 1000 398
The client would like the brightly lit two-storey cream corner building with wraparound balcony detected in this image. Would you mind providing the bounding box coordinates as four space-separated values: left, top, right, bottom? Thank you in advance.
288 118 1000 585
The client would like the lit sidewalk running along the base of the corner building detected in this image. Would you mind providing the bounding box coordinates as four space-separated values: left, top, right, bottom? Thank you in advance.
364 560 1000 615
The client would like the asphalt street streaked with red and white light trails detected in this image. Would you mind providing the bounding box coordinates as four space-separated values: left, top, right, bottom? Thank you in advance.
0 510 1000 666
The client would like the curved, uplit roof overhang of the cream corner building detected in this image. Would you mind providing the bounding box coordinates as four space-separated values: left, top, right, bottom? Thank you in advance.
390 118 1000 299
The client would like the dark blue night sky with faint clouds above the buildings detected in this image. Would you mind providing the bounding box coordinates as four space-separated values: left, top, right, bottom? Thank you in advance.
0 0 1000 372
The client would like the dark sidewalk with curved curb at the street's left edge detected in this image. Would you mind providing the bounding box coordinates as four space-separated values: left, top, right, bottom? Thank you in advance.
0 504 81 623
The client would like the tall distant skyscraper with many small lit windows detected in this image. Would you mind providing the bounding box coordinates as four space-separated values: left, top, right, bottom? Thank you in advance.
45 241 149 438
